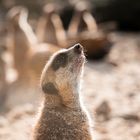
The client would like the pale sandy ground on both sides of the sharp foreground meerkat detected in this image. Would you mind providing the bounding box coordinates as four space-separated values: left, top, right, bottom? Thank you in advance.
0 33 140 140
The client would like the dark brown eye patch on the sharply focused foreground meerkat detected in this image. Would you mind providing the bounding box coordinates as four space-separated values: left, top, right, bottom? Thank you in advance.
52 53 68 71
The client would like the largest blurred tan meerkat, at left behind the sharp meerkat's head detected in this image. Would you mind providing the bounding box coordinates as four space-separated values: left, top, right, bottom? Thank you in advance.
8 7 59 82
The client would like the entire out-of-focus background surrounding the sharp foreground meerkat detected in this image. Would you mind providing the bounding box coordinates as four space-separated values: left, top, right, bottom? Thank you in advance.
0 0 140 140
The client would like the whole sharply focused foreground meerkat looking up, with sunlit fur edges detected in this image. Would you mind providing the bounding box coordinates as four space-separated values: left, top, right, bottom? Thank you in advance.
32 44 93 140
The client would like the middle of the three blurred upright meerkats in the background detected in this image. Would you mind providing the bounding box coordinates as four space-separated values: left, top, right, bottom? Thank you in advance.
37 4 66 47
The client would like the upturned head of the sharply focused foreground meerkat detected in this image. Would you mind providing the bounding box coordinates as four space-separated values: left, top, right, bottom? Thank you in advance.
41 44 85 106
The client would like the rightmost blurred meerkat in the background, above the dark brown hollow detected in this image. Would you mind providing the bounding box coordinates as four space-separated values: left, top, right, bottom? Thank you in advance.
68 2 98 36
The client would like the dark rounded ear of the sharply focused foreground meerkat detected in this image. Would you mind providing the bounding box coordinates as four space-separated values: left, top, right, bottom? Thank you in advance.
42 82 59 95
